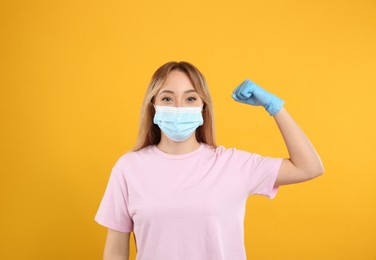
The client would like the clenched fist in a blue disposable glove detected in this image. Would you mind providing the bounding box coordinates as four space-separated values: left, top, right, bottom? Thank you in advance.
232 79 285 116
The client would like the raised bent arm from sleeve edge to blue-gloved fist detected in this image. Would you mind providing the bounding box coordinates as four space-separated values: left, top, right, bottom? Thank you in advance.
232 80 324 186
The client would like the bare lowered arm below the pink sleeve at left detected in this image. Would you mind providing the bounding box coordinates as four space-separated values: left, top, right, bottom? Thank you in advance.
103 228 131 260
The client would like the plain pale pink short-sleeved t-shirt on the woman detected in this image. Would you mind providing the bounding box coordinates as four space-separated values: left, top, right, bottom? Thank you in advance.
95 143 282 260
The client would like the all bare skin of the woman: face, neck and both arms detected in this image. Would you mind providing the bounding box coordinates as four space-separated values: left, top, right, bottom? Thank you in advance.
104 71 324 260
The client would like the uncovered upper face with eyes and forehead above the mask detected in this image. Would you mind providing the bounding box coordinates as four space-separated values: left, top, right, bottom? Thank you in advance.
154 70 203 107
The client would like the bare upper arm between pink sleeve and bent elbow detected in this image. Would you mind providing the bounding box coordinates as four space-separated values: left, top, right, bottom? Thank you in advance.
274 159 320 187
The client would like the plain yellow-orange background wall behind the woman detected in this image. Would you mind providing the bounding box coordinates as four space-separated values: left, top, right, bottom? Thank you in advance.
0 0 376 260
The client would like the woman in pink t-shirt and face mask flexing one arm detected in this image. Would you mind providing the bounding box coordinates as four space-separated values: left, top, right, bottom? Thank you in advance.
95 62 324 260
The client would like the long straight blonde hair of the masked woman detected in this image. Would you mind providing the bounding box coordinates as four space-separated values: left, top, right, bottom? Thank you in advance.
133 61 216 151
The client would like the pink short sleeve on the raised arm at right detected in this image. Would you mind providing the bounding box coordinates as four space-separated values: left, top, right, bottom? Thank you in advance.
236 150 283 199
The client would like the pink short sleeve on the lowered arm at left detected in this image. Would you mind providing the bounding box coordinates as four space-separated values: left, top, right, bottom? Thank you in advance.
94 160 133 233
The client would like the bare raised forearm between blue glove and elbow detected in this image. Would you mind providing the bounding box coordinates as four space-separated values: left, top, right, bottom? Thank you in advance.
274 108 324 175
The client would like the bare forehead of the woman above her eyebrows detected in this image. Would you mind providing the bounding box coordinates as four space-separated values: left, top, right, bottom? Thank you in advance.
160 70 195 92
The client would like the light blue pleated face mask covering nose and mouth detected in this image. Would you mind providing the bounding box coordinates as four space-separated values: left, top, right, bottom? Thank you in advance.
153 106 204 142
